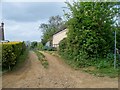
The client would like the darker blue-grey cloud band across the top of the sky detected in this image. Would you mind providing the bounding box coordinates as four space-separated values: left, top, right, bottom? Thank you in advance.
3 2 65 22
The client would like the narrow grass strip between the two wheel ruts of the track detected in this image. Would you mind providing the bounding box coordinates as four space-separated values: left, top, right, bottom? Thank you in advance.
34 50 49 69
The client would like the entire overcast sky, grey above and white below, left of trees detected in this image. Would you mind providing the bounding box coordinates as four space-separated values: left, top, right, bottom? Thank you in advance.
0 2 66 41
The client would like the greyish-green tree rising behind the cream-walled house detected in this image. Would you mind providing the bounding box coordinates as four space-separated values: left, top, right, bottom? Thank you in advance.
40 15 64 45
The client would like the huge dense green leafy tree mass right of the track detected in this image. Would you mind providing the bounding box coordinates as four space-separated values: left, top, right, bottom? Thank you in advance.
60 2 119 68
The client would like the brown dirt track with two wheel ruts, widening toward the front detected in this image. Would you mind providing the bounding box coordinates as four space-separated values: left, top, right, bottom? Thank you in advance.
2 51 118 88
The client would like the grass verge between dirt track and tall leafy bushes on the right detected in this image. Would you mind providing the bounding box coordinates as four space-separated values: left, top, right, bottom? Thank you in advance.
47 51 119 78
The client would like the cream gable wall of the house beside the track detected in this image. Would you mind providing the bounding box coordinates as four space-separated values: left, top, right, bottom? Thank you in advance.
52 29 67 47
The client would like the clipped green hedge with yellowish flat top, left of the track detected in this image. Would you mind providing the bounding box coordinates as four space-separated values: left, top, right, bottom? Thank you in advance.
2 42 26 70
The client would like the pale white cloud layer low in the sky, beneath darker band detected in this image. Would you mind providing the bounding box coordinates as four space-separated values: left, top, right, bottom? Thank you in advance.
5 20 45 41
